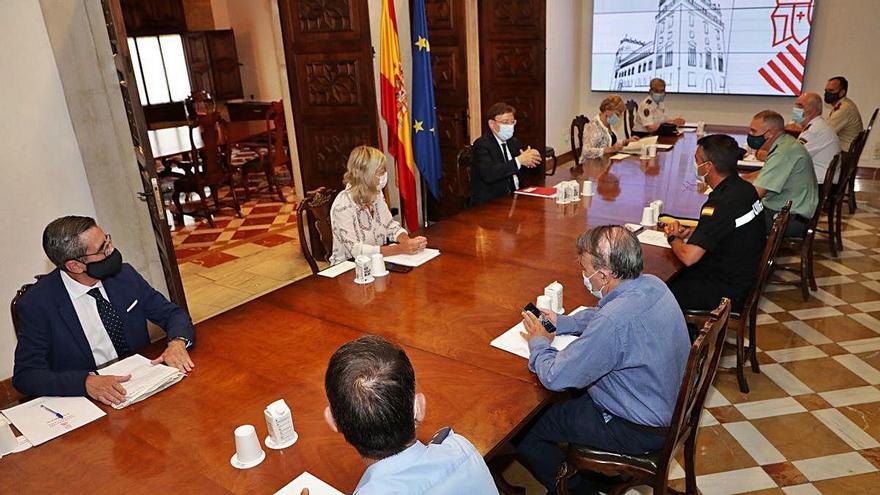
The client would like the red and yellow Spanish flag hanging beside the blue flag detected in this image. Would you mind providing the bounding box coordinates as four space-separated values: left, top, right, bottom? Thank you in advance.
379 0 419 230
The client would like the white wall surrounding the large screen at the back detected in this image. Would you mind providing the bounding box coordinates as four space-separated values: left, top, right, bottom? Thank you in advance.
572 0 880 167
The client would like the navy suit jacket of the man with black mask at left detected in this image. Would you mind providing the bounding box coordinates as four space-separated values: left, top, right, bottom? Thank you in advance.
12 263 195 396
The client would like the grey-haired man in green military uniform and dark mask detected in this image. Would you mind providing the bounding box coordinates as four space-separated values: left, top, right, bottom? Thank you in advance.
743 110 819 237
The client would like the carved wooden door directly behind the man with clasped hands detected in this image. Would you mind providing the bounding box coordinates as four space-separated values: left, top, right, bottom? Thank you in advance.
479 0 546 180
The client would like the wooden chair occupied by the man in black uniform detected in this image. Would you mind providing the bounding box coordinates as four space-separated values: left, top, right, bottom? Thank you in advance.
684 201 791 394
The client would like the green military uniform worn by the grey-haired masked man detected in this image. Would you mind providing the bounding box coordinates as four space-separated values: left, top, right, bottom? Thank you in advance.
755 134 819 236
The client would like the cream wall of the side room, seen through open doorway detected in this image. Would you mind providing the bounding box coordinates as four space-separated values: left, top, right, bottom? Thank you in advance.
211 0 282 101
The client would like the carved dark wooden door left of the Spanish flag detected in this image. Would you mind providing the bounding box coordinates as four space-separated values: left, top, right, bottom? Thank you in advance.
279 0 379 191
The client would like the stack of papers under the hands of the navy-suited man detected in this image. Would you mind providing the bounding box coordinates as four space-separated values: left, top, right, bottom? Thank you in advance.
98 354 186 409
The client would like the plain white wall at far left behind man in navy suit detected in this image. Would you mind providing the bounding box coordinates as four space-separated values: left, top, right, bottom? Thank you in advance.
0 0 95 380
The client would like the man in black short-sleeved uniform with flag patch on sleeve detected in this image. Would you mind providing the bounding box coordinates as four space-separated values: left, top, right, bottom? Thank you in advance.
665 134 765 311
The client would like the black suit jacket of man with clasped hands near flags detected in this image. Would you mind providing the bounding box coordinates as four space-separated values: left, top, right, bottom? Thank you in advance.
468 130 523 206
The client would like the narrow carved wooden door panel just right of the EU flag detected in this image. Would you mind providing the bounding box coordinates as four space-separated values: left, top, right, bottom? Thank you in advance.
422 0 476 221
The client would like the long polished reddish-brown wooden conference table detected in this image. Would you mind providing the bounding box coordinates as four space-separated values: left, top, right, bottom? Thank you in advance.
0 127 743 494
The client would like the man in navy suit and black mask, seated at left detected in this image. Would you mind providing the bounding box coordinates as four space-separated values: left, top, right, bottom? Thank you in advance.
12 216 195 405
